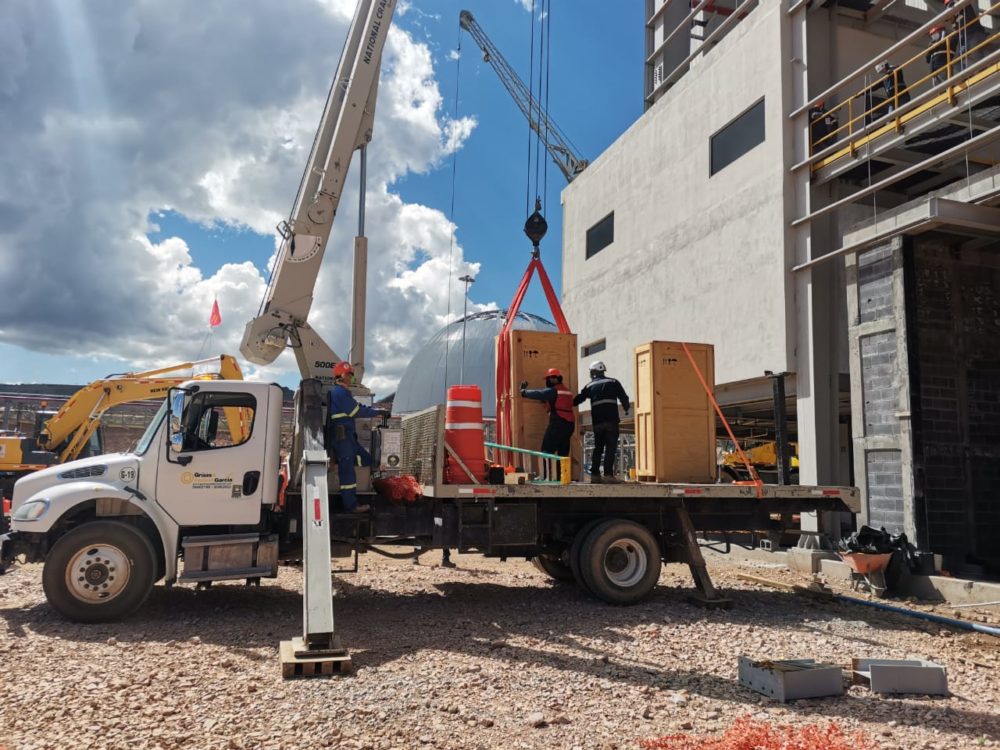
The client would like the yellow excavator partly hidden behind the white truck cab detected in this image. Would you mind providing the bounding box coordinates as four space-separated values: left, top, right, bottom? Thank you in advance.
0 354 244 497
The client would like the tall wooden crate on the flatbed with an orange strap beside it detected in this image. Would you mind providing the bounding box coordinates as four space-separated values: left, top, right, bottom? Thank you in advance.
635 341 716 483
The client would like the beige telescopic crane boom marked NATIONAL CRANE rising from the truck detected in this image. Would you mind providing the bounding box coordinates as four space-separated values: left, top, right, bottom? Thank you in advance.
240 0 396 382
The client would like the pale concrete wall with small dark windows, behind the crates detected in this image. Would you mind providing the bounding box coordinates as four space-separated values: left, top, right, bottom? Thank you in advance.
562 0 793 400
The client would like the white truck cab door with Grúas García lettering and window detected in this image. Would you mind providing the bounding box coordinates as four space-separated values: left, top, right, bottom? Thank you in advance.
156 386 268 526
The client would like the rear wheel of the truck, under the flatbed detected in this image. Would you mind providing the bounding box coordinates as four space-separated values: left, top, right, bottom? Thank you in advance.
580 520 662 604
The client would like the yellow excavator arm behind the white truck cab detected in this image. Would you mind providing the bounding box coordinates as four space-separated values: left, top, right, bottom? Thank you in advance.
38 354 248 463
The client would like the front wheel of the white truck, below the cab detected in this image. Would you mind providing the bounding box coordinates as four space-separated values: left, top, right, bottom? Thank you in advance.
42 521 156 622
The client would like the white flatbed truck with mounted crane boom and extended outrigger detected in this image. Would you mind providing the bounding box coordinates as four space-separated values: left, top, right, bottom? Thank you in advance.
0 0 859 676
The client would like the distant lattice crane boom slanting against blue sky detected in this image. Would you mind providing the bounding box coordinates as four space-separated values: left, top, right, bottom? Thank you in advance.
458 10 590 182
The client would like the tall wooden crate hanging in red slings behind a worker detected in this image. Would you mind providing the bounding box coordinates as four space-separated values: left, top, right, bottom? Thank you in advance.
498 330 583 479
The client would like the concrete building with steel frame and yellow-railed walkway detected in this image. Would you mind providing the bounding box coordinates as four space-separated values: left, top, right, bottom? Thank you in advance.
562 0 1000 568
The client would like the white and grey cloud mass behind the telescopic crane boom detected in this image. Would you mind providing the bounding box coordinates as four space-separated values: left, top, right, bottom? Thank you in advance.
0 0 478 400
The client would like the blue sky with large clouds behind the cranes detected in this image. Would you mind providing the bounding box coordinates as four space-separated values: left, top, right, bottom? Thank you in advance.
0 0 644 389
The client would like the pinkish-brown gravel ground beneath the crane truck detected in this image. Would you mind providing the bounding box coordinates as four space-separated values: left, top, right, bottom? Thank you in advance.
0 552 1000 750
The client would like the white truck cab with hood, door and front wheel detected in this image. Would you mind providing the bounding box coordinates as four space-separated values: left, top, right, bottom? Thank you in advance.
0 380 282 622
